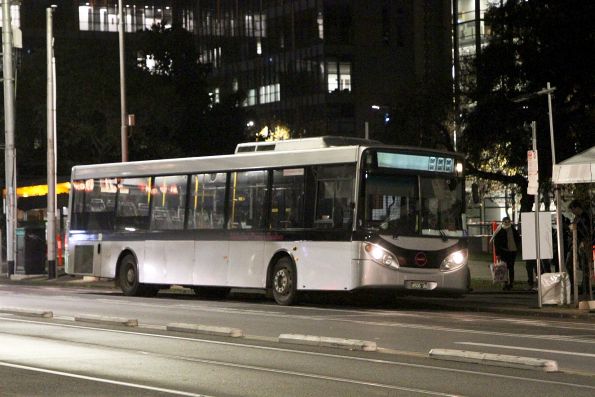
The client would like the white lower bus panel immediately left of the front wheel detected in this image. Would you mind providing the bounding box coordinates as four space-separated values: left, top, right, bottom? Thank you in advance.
227 238 266 288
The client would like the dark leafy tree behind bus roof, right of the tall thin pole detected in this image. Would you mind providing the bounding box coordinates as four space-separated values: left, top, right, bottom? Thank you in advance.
131 25 246 158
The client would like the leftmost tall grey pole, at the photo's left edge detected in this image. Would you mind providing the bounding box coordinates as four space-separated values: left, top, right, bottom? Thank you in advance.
2 0 17 277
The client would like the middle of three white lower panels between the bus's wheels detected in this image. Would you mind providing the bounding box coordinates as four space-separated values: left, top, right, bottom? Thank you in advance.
197 240 229 286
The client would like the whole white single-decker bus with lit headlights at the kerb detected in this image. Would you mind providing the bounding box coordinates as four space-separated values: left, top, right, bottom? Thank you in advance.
65 137 469 305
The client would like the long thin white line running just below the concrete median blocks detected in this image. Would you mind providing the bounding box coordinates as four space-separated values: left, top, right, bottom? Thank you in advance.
2 317 595 390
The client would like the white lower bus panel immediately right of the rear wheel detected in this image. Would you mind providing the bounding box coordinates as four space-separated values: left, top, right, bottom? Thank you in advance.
141 240 194 285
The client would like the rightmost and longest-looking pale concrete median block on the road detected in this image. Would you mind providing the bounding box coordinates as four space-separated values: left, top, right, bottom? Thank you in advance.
429 349 558 372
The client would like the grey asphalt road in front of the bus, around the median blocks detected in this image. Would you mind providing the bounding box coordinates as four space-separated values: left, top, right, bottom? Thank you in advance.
0 285 595 396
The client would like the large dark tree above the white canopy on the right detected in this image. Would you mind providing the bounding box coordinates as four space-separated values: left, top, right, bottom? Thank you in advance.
462 0 595 209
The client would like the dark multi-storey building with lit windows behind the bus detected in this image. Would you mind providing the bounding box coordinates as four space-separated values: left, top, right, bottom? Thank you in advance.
58 0 452 137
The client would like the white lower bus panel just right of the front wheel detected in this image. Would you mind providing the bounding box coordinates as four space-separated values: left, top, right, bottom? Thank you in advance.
294 241 356 291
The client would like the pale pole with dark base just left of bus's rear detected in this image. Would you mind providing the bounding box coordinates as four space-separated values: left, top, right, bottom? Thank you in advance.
46 7 56 279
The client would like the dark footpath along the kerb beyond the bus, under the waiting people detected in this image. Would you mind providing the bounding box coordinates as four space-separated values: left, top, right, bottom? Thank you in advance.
0 260 595 321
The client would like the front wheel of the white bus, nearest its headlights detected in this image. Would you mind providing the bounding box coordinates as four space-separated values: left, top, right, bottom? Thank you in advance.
267 251 298 306
